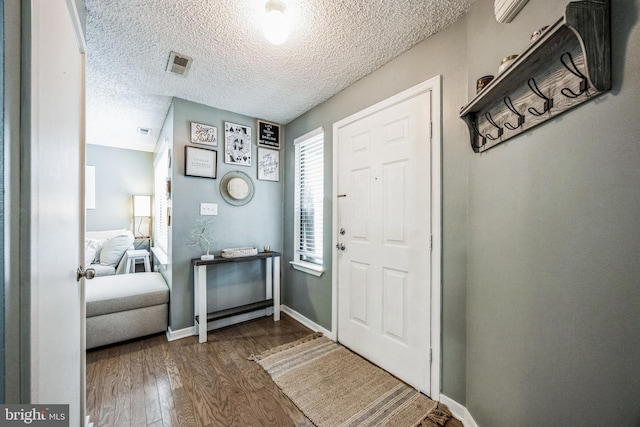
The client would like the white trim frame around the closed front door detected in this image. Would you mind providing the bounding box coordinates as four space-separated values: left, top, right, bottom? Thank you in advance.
330 75 442 400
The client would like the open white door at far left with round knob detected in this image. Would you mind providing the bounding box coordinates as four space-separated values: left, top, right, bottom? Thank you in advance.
29 0 84 426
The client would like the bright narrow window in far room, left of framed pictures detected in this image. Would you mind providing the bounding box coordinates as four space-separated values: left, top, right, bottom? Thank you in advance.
153 143 170 254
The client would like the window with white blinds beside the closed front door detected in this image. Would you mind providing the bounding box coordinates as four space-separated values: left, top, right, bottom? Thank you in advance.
291 128 324 276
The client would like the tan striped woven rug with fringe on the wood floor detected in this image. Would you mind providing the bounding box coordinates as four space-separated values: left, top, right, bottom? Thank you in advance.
249 334 451 427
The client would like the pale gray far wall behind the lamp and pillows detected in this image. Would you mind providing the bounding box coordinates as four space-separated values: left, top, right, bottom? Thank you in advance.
86 144 153 231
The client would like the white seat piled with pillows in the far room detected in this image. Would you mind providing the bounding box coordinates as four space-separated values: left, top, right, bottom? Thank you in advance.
85 229 135 276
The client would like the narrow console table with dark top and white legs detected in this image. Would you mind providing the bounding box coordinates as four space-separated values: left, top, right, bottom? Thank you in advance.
191 252 280 343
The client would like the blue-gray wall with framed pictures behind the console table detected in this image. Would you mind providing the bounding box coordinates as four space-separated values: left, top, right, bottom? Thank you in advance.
170 99 283 330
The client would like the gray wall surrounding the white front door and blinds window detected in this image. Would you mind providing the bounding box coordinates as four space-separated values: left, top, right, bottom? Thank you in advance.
283 15 471 403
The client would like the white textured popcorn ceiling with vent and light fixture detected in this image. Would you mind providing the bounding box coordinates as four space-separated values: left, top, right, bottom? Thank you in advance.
86 0 474 151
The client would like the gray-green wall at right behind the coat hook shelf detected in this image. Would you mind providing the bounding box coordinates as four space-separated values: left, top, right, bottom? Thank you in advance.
462 0 640 427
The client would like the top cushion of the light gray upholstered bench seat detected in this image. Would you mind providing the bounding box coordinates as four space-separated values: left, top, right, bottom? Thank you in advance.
85 272 169 317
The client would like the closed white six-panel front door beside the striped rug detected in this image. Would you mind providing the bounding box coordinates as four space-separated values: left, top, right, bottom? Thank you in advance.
334 82 431 394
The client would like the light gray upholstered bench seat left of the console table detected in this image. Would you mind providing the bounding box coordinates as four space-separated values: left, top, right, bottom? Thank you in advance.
85 272 169 349
